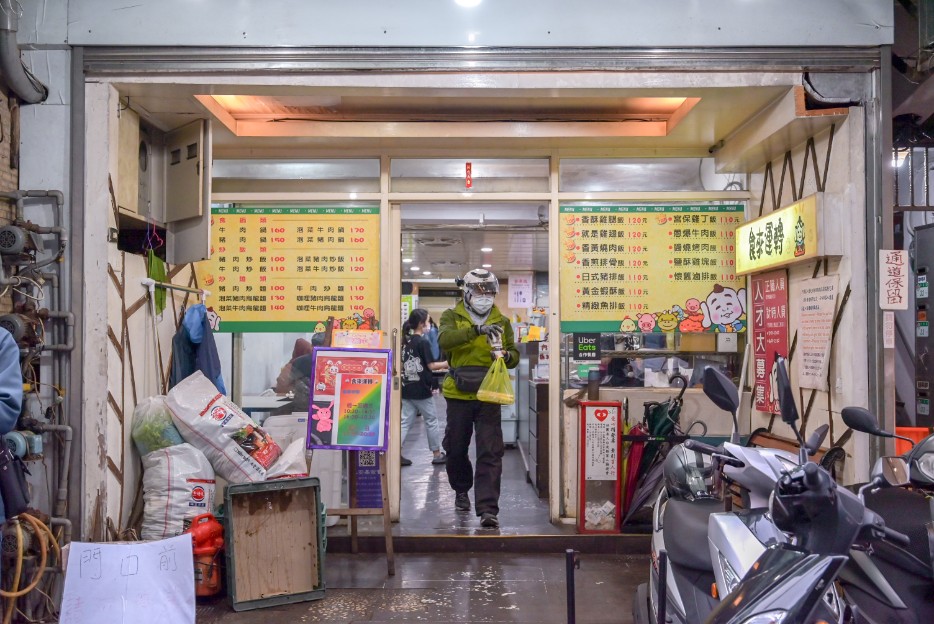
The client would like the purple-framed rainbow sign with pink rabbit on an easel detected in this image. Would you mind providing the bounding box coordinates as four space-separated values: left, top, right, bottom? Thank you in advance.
306 347 392 451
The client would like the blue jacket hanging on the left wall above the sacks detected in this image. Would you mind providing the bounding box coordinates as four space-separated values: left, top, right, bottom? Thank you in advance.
169 303 227 394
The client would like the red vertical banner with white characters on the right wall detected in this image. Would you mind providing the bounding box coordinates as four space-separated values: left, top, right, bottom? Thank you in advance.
751 269 788 414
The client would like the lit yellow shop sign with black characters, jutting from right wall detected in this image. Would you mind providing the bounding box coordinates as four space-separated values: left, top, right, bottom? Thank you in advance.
736 193 832 275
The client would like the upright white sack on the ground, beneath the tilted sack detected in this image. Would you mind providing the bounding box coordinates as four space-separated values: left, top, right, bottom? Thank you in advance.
140 444 214 540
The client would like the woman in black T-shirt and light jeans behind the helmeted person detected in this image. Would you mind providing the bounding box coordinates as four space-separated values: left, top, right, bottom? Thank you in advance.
399 308 447 466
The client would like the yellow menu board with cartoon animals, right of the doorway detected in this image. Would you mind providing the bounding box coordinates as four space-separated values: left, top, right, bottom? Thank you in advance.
559 204 746 333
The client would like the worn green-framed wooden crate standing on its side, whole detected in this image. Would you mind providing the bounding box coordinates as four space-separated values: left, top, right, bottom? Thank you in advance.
224 477 327 611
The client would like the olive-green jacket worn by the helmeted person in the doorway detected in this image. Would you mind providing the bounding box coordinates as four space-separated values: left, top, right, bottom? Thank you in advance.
438 301 519 401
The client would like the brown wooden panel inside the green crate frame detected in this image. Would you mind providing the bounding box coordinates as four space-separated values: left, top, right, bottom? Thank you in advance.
228 488 322 602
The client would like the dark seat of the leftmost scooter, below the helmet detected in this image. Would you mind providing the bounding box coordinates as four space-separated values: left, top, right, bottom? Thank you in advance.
662 499 723 572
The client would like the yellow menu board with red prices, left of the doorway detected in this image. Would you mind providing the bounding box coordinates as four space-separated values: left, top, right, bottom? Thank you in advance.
195 206 380 332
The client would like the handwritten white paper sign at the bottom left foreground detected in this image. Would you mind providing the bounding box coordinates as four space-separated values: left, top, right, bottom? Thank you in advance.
59 534 195 624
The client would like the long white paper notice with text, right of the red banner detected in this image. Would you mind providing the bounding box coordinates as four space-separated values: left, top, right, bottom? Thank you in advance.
792 275 838 390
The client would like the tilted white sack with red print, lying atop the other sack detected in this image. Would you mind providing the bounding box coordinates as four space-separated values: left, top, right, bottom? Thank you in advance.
166 371 282 483
